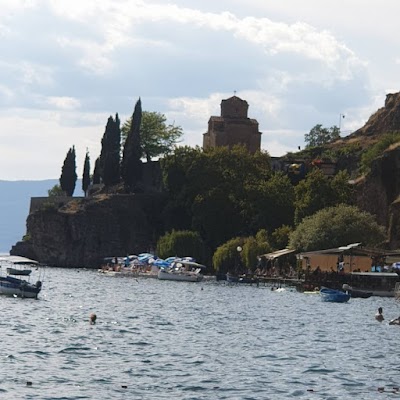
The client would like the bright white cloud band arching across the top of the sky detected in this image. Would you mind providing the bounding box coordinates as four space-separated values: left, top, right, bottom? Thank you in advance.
43 0 362 79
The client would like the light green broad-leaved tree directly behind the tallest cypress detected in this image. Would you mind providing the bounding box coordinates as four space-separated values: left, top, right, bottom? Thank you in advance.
122 111 183 161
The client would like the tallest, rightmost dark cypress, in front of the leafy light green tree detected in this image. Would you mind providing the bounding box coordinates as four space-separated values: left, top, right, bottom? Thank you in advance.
121 98 142 193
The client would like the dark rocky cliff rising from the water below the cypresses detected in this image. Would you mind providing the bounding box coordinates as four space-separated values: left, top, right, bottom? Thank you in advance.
11 193 165 267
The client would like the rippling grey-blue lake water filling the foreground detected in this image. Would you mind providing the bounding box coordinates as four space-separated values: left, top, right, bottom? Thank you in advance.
0 268 400 400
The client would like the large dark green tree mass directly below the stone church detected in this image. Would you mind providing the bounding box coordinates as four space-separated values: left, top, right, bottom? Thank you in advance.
161 146 274 249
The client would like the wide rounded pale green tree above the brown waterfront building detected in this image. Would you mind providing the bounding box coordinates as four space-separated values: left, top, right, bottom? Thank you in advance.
289 204 386 251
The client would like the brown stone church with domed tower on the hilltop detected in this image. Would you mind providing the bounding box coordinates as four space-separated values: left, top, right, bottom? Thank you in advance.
203 96 261 154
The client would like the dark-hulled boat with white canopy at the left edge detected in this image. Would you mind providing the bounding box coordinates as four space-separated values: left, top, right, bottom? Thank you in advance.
0 256 42 299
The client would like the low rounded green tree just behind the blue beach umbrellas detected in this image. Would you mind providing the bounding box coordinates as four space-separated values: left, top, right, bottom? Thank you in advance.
157 230 208 264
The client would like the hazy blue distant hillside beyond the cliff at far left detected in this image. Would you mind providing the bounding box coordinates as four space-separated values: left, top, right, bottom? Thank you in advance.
0 179 81 253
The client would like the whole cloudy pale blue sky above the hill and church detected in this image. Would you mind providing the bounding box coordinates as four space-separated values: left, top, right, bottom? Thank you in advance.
0 0 400 180
